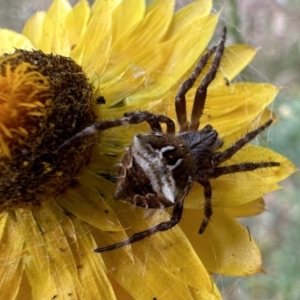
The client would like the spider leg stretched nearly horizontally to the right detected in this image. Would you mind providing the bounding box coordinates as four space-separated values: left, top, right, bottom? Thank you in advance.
200 161 280 179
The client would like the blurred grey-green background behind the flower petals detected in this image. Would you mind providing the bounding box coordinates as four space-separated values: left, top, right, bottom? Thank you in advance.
0 0 300 300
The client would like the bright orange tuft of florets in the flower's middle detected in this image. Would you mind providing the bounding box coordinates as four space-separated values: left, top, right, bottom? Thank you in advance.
0 57 50 158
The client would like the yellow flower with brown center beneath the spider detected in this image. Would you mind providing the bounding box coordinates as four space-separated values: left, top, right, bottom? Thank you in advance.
0 0 294 300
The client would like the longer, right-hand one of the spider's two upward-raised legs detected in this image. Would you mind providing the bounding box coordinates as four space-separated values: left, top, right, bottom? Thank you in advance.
189 27 227 131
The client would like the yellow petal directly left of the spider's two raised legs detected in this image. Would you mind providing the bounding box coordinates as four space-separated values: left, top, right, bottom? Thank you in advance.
127 15 218 103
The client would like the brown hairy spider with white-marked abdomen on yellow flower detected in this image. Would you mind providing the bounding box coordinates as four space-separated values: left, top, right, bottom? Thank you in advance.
60 27 280 252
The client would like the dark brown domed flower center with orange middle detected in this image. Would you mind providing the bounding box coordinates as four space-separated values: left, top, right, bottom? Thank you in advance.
0 50 97 208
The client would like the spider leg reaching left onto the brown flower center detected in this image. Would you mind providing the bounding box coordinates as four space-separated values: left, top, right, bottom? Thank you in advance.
58 111 175 151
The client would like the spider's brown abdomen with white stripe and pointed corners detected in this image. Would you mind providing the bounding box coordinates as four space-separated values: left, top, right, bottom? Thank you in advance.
114 133 195 208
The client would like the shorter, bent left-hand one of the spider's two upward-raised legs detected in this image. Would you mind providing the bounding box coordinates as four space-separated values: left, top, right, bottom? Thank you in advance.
175 47 216 132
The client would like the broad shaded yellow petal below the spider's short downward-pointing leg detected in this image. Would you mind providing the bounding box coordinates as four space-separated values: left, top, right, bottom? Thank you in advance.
180 209 262 276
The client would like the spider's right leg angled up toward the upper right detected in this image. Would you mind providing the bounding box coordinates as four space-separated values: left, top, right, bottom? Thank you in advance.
212 120 273 166
